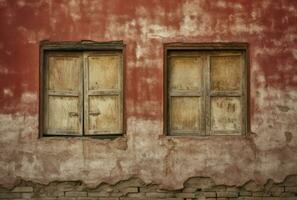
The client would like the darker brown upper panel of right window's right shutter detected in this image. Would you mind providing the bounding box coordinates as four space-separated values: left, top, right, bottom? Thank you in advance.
210 55 242 91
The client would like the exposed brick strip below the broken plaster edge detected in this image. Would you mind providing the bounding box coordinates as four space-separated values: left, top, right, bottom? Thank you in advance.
0 175 297 200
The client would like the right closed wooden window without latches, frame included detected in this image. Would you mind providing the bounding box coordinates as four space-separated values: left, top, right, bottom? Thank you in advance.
164 44 247 135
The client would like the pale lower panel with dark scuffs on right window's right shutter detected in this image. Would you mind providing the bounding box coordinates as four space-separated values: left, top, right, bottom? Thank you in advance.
211 97 242 134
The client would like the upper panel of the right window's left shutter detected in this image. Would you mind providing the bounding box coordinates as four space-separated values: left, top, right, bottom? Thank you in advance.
169 56 203 91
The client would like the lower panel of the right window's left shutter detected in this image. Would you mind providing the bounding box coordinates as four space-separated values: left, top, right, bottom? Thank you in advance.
170 97 202 132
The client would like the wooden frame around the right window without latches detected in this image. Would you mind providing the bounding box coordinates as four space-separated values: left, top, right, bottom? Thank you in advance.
163 42 250 137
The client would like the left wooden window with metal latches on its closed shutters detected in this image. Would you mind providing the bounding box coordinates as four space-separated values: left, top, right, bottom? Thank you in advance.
40 42 124 137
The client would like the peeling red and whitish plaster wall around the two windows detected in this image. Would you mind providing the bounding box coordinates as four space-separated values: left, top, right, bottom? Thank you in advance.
0 0 297 189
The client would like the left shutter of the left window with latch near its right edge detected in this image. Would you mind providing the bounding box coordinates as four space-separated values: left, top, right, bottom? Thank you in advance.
44 52 83 135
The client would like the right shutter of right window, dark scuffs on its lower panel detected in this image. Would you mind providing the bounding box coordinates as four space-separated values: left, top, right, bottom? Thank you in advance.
208 52 246 134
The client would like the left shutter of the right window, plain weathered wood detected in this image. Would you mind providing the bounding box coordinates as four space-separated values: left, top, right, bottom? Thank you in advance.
168 52 205 135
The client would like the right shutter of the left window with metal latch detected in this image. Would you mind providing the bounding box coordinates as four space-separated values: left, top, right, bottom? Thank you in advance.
84 51 123 135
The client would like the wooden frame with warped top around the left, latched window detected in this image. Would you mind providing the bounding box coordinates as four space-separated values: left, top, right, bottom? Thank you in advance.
38 40 126 139
